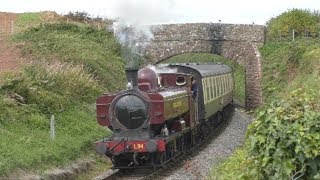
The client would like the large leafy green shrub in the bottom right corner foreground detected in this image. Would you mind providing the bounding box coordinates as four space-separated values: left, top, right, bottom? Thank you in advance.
244 89 320 179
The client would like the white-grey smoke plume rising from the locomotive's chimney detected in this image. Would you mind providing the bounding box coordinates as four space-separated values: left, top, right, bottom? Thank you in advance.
113 0 178 68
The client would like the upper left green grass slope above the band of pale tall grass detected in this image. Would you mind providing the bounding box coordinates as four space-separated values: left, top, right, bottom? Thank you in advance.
14 22 125 92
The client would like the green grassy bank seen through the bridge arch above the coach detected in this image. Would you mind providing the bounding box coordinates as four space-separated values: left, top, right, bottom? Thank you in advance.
163 53 245 103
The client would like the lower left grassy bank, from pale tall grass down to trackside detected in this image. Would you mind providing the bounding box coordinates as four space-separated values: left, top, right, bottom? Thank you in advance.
0 62 108 174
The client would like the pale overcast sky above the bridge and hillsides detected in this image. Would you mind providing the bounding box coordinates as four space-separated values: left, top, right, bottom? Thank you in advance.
0 0 320 25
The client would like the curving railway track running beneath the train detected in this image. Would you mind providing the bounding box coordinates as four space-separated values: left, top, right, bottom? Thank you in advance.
94 105 234 180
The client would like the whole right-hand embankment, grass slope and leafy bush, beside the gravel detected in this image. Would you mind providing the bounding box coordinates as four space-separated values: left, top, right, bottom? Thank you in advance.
209 39 320 179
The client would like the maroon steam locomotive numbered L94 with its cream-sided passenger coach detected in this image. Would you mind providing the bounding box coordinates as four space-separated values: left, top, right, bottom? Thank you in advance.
95 63 234 169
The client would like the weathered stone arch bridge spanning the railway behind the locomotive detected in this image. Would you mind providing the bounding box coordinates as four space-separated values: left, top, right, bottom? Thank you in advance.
144 23 265 109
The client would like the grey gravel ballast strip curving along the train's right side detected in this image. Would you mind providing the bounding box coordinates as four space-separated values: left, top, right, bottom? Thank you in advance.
163 108 253 180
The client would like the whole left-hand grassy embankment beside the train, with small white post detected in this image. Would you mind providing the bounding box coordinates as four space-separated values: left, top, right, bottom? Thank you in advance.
0 14 124 176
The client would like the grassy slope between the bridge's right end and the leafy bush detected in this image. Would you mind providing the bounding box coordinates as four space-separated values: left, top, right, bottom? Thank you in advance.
260 39 320 102
